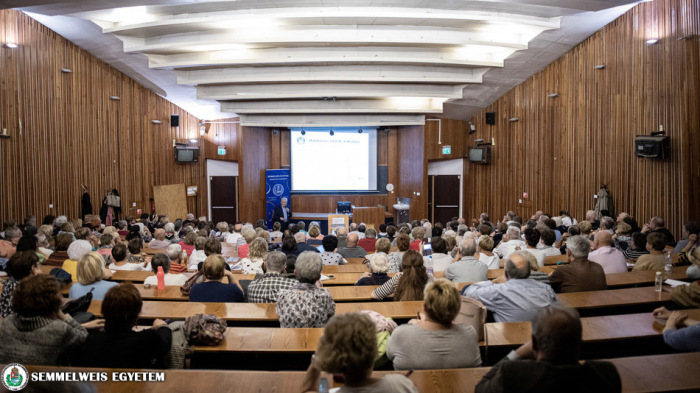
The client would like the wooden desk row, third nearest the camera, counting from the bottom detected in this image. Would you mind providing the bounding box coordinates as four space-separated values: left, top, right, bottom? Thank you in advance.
89 287 670 322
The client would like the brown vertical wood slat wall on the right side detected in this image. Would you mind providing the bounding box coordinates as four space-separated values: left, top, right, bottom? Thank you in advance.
456 0 700 236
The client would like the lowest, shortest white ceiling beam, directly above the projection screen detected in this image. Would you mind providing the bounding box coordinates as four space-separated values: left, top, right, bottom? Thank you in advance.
240 114 425 127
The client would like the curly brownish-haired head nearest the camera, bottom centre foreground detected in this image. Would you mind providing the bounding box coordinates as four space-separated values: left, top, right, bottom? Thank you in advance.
314 313 377 386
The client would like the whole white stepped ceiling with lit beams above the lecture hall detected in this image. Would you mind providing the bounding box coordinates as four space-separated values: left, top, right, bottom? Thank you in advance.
9 0 635 126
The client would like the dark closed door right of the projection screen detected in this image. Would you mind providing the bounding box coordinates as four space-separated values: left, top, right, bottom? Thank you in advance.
428 175 460 224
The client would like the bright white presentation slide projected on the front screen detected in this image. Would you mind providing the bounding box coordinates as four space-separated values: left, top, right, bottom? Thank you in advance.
290 128 377 192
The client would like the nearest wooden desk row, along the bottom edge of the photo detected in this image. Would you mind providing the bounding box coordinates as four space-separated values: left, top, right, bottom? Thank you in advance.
21 353 700 393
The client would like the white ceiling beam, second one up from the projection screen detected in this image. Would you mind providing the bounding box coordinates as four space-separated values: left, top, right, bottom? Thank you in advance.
220 97 445 115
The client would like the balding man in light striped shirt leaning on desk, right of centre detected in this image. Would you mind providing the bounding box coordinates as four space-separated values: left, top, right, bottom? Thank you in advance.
462 254 557 322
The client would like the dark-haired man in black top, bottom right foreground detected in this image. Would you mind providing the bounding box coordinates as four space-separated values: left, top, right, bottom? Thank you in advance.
476 304 622 392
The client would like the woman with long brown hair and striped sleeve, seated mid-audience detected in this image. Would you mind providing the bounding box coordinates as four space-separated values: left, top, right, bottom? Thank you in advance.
372 250 431 301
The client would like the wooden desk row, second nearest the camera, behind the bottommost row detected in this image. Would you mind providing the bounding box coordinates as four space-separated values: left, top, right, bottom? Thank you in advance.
190 309 700 353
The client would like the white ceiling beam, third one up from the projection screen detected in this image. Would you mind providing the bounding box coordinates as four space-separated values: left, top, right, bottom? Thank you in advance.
197 83 466 101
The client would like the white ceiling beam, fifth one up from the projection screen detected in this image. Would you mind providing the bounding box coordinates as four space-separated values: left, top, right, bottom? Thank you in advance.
147 46 503 69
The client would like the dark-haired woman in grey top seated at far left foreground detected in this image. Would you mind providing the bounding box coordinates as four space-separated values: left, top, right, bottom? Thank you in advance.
0 274 96 366
